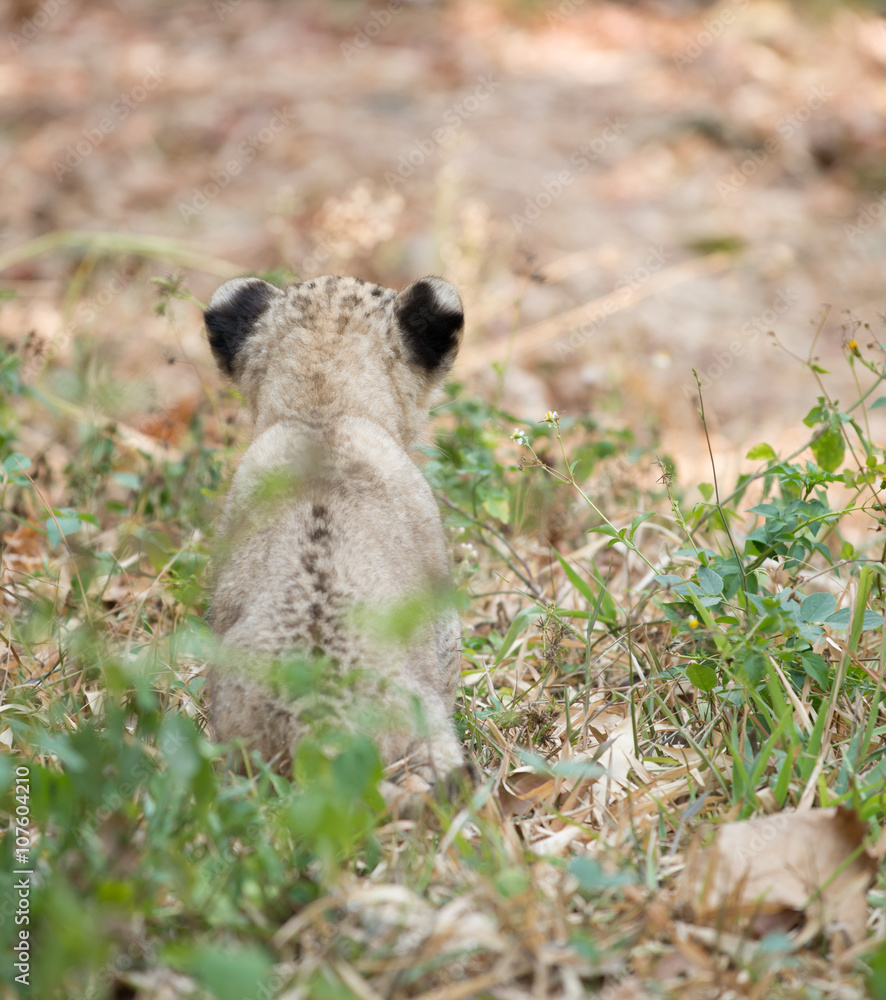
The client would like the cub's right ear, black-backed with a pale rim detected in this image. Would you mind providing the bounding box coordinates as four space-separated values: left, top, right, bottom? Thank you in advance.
394 277 465 378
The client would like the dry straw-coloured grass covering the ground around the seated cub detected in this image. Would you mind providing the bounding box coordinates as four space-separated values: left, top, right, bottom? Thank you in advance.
0 290 886 1000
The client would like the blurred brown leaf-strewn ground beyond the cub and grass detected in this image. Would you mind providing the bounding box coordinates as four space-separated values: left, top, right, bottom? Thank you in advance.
0 0 886 482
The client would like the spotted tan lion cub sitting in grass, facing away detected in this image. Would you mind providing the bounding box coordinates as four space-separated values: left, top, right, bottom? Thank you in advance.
205 277 464 802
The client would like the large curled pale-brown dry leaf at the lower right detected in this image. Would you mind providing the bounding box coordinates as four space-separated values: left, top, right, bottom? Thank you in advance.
679 807 876 944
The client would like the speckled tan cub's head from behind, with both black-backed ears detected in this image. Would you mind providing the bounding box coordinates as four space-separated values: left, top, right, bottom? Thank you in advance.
204 277 464 444
